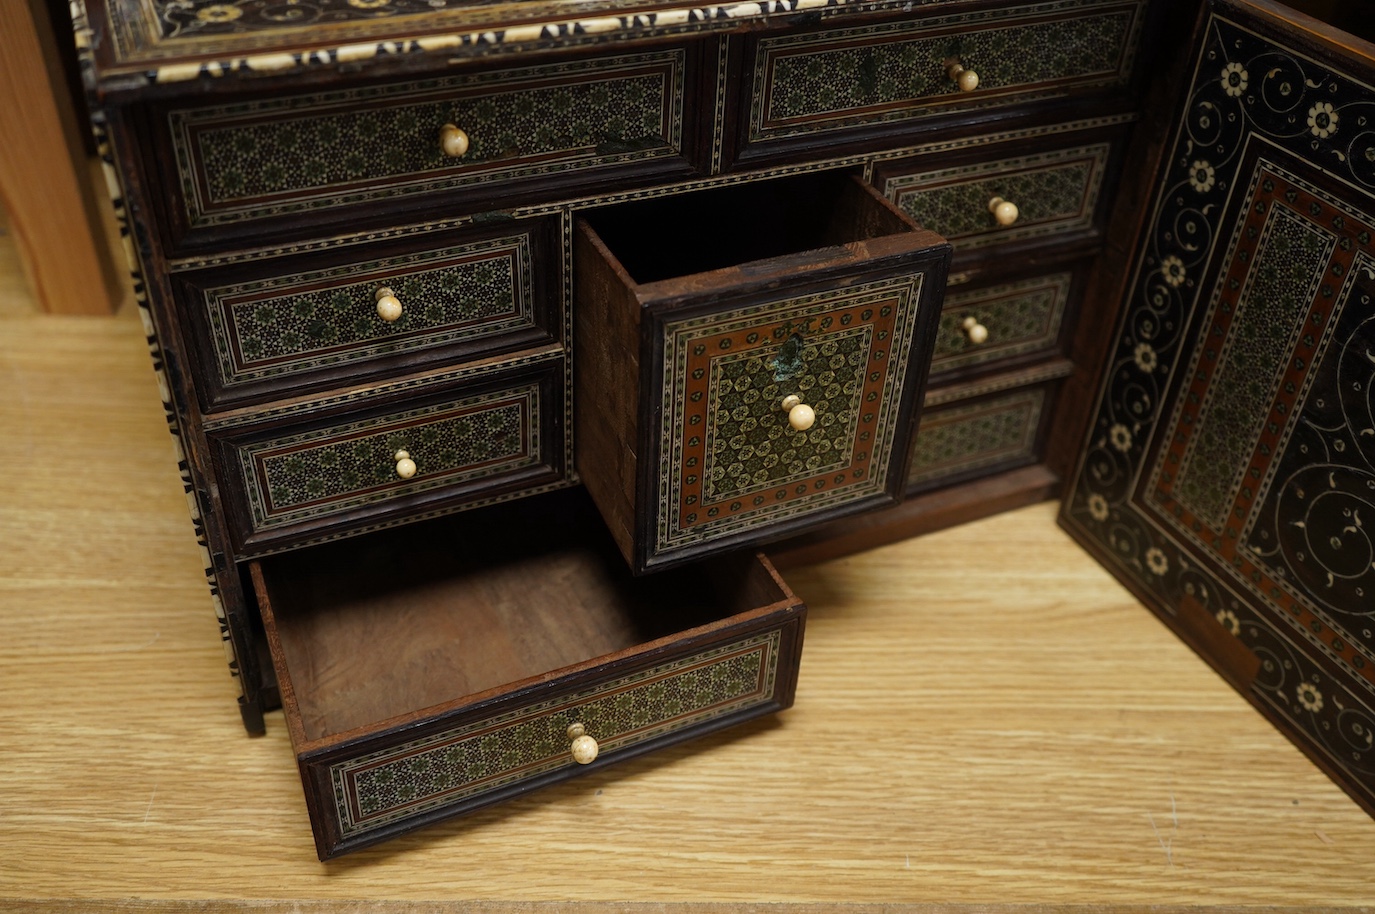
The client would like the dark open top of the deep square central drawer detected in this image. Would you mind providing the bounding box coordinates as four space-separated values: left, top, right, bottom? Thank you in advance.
583 172 913 285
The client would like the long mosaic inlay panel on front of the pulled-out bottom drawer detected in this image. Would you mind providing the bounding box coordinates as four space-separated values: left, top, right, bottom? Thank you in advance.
329 629 781 836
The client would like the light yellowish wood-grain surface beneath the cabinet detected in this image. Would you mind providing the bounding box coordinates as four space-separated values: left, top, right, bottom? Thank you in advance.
0 204 1375 914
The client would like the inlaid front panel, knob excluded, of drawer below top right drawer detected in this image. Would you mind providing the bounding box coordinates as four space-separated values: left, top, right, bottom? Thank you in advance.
880 142 1114 250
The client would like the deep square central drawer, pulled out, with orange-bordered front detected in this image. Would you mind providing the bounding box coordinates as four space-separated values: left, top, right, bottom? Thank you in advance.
573 173 950 570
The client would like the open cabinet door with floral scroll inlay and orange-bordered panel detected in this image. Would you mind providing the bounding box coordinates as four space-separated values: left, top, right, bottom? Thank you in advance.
1063 8 1375 796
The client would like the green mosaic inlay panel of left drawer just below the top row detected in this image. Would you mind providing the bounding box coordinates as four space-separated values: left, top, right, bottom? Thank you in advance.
202 235 532 385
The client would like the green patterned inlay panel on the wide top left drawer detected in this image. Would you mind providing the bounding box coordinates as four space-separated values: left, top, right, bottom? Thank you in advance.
171 51 682 225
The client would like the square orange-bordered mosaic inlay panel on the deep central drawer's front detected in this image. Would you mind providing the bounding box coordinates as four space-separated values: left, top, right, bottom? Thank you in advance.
656 275 921 551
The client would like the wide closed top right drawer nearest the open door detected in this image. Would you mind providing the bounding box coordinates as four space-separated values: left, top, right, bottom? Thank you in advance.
738 0 1147 161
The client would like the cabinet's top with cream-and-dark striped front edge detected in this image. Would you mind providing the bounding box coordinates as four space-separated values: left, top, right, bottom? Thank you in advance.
69 0 1147 95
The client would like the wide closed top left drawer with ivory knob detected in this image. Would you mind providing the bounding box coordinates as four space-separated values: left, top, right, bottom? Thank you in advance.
156 45 700 243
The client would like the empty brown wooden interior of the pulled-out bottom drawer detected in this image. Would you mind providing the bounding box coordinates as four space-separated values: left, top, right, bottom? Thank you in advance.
250 491 796 752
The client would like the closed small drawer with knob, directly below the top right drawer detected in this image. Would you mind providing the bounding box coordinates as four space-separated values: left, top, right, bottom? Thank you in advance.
873 131 1122 253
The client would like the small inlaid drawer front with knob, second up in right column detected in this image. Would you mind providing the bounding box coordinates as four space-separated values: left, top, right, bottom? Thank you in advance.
931 272 1074 374
